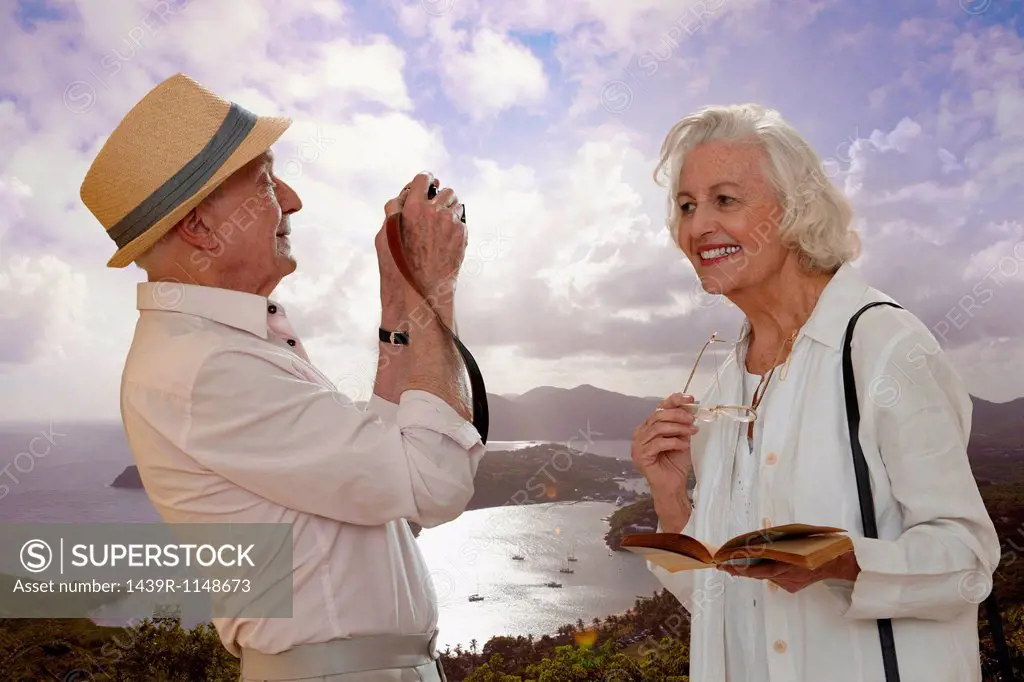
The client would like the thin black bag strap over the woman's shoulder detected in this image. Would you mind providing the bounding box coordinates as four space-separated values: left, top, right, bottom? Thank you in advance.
843 301 1016 682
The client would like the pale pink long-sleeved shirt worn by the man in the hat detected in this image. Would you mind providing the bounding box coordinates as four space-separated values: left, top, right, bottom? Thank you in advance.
121 283 485 655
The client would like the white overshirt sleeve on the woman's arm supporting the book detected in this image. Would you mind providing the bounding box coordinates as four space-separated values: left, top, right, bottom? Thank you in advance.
829 308 1000 620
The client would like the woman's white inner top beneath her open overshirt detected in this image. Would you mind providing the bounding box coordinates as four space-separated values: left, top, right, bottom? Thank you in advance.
723 370 778 682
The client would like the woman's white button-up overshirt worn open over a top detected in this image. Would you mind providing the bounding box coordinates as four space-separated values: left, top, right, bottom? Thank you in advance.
648 265 999 682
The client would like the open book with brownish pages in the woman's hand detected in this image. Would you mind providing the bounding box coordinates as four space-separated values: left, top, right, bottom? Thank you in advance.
622 523 853 573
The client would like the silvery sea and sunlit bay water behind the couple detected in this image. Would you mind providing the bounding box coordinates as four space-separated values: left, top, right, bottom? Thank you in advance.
0 425 660 649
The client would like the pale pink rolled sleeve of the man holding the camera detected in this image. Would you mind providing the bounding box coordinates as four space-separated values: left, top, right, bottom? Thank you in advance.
182 348 485 527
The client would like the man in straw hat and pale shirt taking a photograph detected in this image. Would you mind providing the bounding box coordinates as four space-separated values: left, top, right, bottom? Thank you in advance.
81 74 485 682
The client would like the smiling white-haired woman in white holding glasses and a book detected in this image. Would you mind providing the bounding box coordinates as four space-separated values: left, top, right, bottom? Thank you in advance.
633 105 999 682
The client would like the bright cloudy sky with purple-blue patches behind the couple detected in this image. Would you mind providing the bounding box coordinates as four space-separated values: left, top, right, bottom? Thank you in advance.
0 0 1024 421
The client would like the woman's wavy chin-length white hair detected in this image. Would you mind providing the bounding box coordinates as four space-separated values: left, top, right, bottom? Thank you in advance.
654 104 860 272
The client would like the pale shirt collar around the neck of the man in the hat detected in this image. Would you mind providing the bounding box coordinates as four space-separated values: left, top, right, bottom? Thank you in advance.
136 282 285 339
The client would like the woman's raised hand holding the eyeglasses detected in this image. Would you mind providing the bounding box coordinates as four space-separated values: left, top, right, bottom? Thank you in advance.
631 393 697 532
